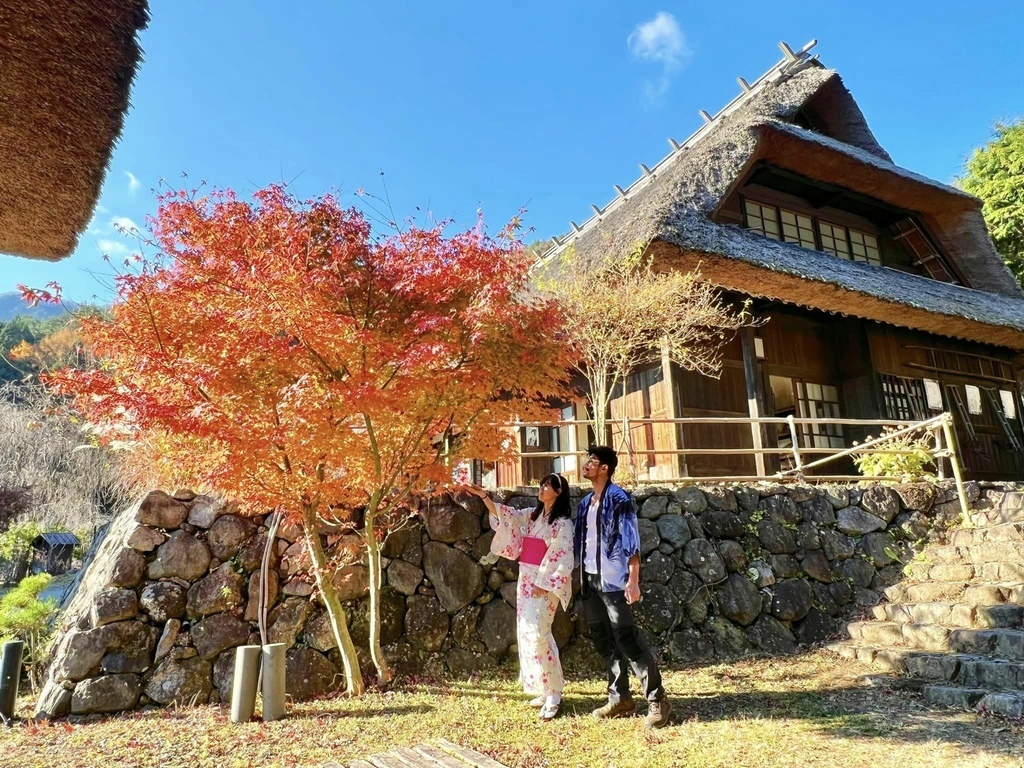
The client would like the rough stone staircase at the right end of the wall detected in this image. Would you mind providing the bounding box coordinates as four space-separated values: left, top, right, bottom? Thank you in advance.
828 490 1024 718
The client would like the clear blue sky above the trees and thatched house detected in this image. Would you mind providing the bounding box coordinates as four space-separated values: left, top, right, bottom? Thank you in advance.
6 0 1024 301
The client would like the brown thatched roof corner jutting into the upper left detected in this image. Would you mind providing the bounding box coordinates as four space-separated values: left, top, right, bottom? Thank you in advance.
0 0 148 260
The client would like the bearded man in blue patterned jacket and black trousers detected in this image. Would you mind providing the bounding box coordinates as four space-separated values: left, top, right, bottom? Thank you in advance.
572 445 672 728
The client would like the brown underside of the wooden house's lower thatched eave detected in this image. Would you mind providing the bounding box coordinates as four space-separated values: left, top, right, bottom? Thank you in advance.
649 241 1024 350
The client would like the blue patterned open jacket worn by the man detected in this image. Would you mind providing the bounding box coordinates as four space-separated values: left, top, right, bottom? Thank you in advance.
572 483 640 592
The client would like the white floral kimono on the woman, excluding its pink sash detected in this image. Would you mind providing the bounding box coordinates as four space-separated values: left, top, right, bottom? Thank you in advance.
490 504 572 695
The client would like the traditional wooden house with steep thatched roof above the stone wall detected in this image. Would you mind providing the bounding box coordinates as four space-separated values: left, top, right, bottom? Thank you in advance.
497 43 1024 484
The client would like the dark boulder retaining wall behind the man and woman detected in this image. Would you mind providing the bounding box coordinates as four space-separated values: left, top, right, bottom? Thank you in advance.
37 483 978 717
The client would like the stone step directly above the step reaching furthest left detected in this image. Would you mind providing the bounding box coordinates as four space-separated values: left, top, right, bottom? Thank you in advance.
847 622 1024 662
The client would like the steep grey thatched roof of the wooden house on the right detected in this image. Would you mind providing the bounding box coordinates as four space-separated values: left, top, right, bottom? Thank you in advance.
546 43 1024 349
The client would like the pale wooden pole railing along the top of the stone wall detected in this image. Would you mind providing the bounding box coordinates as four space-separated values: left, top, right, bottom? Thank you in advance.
506 413 967 515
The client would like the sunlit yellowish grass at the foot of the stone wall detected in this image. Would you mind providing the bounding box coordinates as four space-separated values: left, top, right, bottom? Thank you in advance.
0 653 1024 768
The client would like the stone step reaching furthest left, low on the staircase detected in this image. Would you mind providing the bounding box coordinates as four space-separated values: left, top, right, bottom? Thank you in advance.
825 641 1024 691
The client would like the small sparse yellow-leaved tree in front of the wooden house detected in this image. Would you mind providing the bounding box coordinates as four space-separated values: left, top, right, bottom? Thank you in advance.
536 246 757 454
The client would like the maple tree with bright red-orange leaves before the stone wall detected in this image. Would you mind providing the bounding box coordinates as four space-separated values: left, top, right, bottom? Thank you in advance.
51 186 566 694
